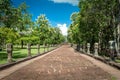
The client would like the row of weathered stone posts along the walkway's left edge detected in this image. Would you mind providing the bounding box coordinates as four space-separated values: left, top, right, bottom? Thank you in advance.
6 43 45 63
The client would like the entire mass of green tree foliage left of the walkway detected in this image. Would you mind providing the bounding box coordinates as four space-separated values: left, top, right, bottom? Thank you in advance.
0 0 63 49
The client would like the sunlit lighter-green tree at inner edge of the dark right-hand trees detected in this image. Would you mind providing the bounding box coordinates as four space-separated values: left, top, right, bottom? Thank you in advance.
68 12 81 44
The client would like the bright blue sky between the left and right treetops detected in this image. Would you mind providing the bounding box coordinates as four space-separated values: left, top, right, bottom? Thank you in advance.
12 0 79 35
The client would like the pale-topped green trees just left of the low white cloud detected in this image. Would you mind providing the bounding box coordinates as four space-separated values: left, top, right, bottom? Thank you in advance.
36 14 63 44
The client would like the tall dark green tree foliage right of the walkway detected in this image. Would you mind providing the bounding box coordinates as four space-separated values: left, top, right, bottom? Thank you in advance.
68 0 120 52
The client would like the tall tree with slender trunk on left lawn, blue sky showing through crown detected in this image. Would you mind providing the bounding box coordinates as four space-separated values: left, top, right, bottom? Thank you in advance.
15 3 33 48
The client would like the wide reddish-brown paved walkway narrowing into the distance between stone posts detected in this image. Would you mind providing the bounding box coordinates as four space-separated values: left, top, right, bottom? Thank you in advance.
0 45 120 80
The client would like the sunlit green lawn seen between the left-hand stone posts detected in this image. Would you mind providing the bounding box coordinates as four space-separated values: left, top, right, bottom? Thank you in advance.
0 46 55 65
